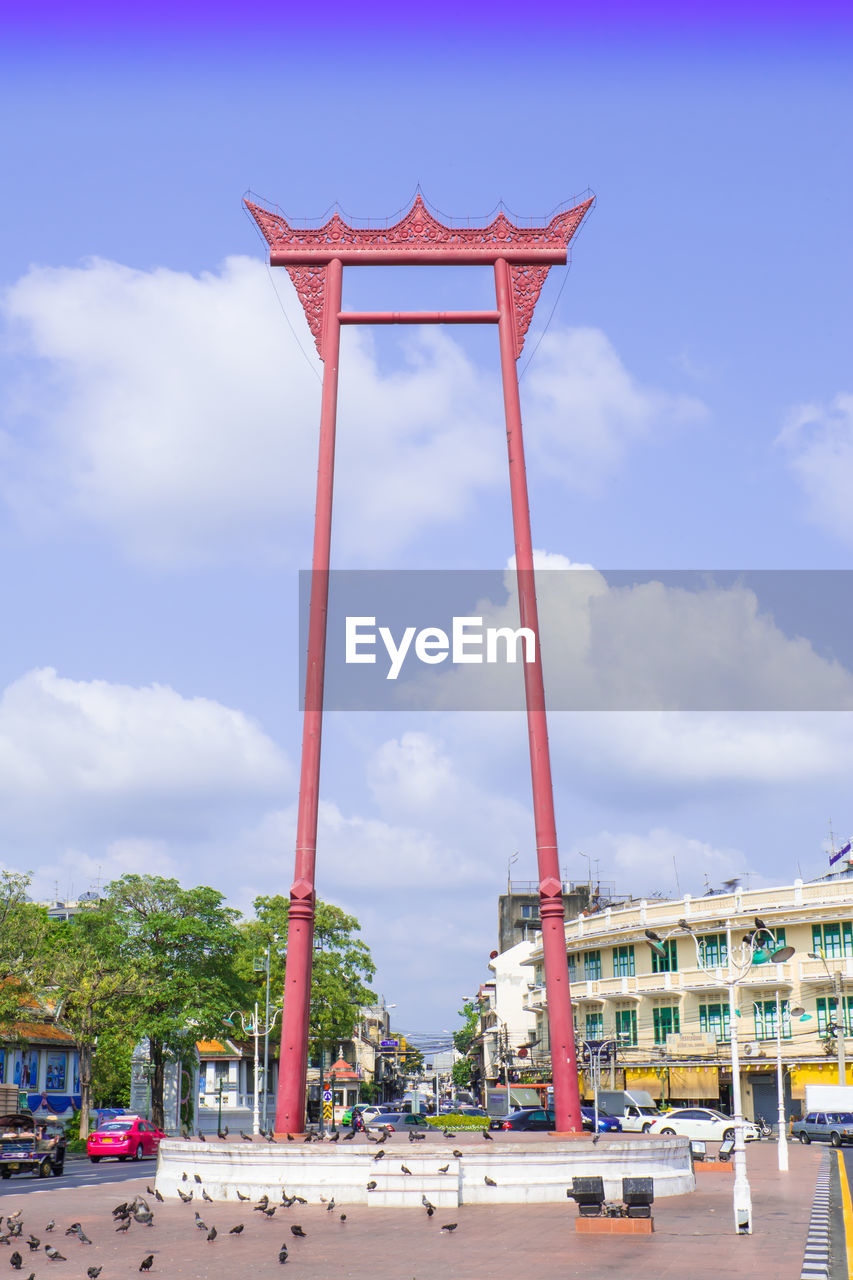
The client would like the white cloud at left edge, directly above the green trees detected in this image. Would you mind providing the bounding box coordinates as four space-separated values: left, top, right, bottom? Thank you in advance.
0 668 289 844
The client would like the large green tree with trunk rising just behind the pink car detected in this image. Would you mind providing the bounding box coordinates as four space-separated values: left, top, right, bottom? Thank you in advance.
108 876 246 1128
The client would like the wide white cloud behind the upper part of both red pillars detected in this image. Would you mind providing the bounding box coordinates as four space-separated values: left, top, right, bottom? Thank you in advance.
0 257 703 563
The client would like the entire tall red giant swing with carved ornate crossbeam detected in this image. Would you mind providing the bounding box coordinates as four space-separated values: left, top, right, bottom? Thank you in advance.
246 192 593 1133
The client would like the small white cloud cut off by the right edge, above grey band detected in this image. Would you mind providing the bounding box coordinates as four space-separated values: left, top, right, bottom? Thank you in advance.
776 392 853 543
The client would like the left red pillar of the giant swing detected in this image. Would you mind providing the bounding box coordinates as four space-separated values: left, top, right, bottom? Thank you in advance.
275 257 343 1133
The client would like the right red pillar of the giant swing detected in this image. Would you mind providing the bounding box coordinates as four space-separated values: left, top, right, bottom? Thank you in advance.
494 257 583 1133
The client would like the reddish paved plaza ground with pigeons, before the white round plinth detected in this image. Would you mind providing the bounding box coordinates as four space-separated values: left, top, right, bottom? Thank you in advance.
0 1135 824 1280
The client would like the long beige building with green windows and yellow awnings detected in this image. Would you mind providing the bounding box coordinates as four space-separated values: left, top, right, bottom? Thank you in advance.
526 869 853 1120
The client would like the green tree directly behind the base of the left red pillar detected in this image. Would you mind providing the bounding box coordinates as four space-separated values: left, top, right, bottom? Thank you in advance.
234 893 377 1070
